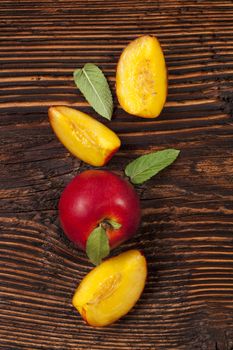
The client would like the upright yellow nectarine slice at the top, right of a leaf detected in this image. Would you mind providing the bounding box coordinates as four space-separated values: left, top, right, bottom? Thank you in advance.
116 35 167 118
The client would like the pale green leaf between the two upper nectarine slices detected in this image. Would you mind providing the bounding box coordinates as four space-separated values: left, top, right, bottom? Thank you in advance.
74 63 113 120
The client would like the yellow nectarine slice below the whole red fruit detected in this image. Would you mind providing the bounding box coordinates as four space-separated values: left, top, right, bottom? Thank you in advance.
73 250 147 327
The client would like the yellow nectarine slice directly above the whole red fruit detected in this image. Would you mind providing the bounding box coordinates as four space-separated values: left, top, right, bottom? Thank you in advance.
49 106 121 166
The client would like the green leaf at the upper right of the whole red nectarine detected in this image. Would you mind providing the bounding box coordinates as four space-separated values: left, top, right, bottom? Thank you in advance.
125 148 180 184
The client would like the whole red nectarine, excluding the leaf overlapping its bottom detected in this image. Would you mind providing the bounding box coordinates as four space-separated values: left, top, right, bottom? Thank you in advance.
59 170 141 250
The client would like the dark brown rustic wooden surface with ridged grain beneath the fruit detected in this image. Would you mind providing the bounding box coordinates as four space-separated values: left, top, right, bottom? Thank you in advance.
0 0 233 350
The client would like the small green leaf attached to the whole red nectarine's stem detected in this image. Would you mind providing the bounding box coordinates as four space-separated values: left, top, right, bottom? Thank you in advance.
86 225 110 265
